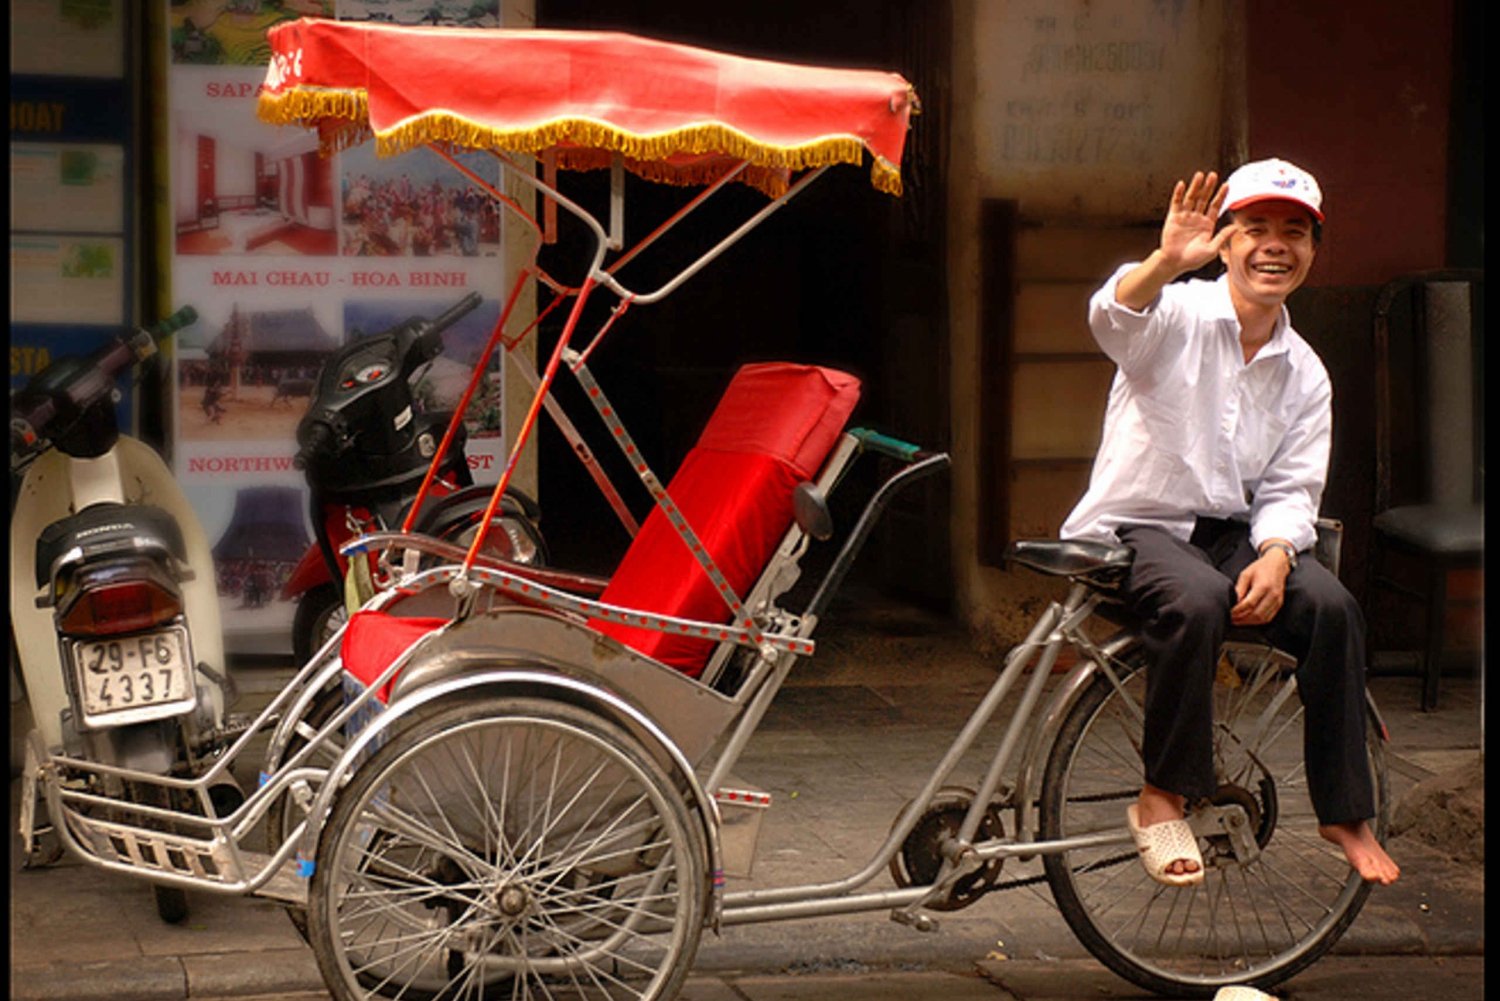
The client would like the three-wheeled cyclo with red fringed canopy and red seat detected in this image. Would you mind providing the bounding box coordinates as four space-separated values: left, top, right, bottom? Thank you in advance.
17 20 1388 998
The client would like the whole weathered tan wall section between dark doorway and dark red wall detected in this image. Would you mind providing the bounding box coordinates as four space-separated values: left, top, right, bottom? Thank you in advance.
950 0 1245 645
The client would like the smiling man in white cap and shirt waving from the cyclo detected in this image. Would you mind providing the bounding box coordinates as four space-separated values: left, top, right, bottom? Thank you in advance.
1062 159 1400 885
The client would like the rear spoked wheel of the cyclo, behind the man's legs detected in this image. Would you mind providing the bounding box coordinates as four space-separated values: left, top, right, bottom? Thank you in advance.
1041 642 1389 996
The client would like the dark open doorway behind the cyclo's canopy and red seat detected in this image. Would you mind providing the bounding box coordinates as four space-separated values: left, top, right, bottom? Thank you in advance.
537 0 953 609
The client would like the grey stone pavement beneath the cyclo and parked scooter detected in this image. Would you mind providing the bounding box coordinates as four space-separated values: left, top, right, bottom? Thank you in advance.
11 591 1484 1001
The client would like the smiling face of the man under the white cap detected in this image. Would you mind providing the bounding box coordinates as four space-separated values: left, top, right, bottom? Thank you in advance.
1220 200 1317 306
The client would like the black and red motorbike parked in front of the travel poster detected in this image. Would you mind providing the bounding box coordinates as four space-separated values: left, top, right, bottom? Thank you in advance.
282 293 546 663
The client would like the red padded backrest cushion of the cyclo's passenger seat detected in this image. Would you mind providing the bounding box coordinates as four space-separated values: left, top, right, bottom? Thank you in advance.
590 362 860 677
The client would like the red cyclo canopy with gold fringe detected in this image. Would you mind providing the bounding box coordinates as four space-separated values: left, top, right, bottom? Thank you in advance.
258 18 917 194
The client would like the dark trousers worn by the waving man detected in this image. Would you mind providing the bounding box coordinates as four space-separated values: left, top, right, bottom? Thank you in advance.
1116 518 1376 824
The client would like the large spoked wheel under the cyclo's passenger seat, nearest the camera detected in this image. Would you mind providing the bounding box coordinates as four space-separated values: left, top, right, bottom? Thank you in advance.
309 698 707 1001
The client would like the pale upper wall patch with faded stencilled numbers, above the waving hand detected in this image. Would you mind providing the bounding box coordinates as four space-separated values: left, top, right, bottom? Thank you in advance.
959 0 1242 222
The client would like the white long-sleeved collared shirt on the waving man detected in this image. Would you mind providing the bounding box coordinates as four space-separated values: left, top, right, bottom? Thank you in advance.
1061 264 1334 551
